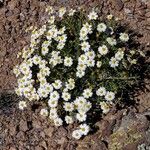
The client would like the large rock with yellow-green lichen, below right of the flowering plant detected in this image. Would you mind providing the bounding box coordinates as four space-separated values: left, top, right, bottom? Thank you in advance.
108 111 149 150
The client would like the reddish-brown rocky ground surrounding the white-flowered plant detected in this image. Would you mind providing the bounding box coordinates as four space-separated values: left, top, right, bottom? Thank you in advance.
0 0 150 150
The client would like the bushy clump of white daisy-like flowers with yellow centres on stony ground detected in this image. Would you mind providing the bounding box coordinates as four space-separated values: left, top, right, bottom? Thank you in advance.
14 7 143 139
